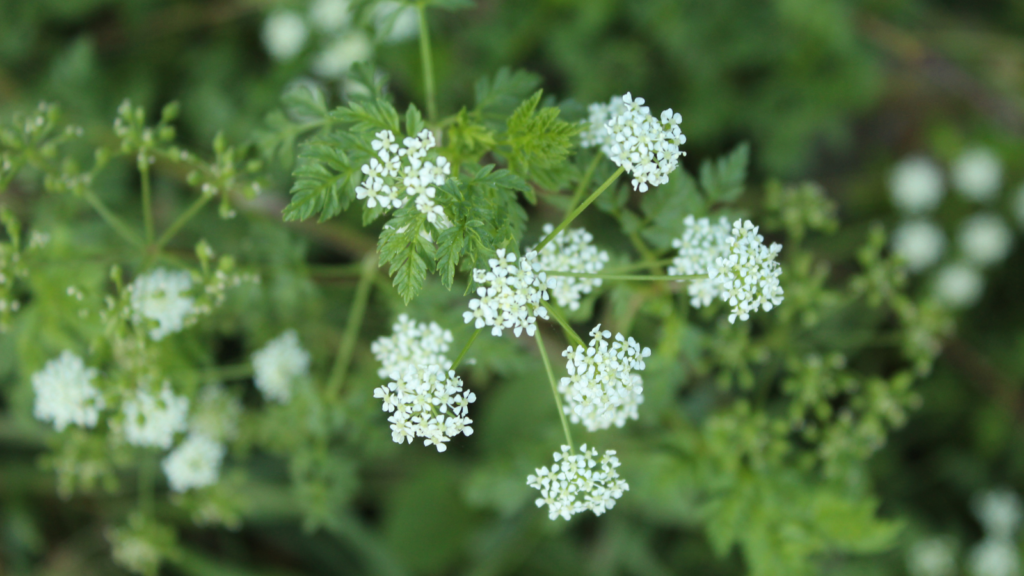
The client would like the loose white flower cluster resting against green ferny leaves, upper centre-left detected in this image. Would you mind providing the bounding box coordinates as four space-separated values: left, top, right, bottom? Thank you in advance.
355 130 452 228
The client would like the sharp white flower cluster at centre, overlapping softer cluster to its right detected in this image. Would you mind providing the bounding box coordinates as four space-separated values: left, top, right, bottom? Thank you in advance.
462 248 549 337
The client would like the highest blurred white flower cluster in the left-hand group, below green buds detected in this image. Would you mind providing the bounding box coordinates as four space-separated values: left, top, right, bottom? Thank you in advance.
128 268 196 341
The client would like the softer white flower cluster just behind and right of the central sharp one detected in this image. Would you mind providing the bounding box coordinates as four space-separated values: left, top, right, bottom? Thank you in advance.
535 223 608 310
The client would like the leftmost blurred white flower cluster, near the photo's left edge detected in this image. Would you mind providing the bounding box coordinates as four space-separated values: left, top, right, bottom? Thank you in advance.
32 351 106 431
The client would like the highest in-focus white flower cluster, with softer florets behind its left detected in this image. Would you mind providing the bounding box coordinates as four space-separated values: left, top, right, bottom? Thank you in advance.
582 93 686 192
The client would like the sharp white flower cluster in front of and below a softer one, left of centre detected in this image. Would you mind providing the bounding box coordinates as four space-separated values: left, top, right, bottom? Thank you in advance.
374 365 476 452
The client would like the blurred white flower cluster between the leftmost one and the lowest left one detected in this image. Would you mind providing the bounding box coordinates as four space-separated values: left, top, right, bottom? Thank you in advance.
121 381 188 450
